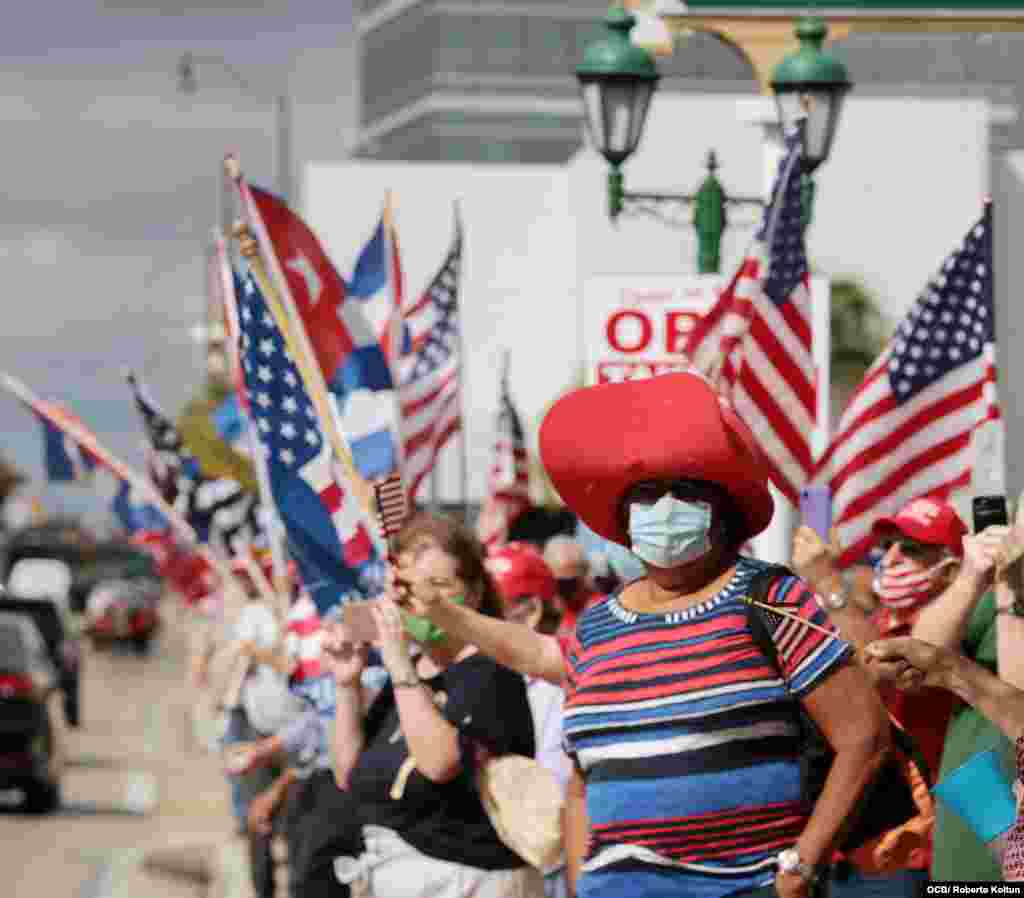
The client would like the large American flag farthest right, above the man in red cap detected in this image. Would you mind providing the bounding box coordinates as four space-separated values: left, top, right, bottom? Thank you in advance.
815 204 1000 562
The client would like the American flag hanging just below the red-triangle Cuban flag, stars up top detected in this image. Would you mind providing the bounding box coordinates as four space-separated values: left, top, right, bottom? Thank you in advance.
238 274 384 613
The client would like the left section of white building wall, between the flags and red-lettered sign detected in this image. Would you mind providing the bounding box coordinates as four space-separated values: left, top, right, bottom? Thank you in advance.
304 162 577 501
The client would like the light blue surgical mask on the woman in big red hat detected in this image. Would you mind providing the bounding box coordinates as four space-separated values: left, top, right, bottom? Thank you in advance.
630 493 712 567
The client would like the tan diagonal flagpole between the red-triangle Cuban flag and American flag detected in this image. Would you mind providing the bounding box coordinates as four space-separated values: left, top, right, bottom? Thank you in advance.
228 214 377 536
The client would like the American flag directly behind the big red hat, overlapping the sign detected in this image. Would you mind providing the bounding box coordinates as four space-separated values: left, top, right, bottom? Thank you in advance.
685 131 817 505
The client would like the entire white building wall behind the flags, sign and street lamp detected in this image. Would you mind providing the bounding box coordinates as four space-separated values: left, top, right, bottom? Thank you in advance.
303 94 989 511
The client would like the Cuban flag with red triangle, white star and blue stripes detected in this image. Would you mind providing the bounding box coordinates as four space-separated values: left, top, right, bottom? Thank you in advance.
239 179 399 480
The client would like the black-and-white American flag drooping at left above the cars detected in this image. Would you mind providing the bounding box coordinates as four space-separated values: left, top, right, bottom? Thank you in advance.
128 375 263 555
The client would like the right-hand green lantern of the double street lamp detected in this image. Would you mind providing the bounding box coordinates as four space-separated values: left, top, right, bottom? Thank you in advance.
771 16 853 227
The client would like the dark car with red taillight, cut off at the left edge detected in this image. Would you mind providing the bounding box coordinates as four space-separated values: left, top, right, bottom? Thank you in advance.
0 611 65 813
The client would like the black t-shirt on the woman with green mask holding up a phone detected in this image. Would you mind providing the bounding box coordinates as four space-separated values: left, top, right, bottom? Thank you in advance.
348 654 535 870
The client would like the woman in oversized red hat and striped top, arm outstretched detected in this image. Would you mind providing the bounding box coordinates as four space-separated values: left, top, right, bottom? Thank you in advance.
397 374 889 898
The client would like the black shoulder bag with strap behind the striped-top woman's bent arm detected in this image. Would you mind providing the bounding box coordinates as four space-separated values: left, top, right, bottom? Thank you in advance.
746 565 931 853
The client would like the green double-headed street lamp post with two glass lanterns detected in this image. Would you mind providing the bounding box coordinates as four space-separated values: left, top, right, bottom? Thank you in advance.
575 3 852 266
